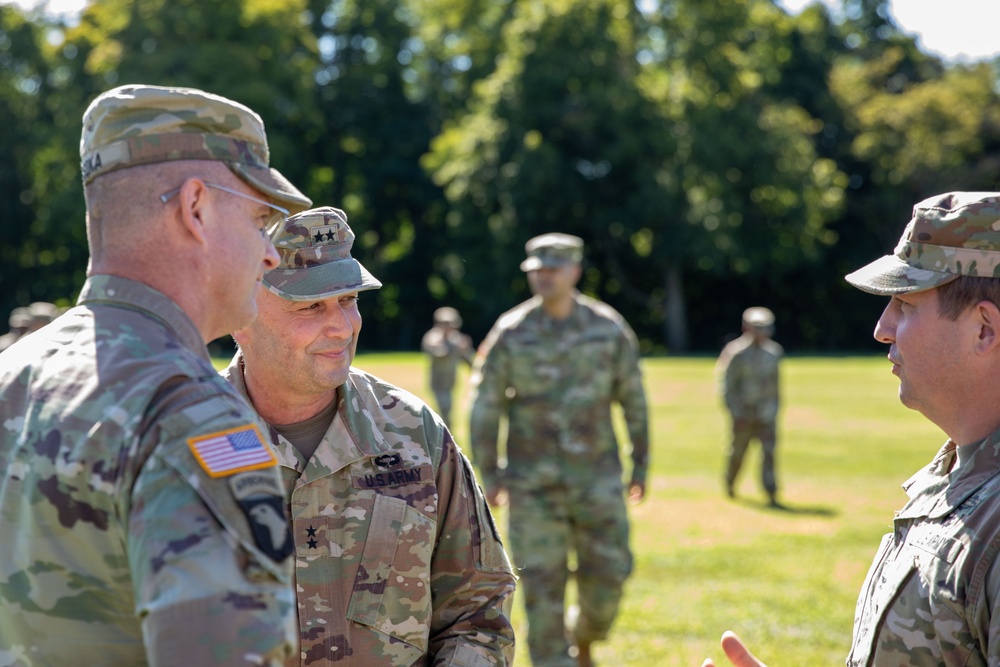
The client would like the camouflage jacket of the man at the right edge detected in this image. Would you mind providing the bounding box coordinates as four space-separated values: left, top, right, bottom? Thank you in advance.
847 431 1000 667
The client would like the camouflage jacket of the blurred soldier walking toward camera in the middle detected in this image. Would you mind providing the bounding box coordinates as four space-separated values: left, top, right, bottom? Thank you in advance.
470 294 649 488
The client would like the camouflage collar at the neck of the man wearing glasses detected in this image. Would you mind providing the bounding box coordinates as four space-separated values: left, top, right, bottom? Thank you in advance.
76 274 211 361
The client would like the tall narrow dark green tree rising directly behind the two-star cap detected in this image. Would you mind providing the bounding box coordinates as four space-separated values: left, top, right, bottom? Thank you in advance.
306 0 460 348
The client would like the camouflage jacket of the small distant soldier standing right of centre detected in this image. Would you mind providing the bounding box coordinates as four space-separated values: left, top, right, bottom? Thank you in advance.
716 334 784 422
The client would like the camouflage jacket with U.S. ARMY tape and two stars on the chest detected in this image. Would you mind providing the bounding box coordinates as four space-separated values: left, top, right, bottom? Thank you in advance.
223 354 514 667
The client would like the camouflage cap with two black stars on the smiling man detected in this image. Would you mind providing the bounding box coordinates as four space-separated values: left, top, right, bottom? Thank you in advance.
264 206 382 301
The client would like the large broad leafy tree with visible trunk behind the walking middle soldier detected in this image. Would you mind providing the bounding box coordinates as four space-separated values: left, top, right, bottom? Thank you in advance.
426 1 846 350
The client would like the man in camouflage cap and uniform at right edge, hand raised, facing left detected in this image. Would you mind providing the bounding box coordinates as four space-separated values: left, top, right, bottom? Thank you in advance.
707 192 1000 667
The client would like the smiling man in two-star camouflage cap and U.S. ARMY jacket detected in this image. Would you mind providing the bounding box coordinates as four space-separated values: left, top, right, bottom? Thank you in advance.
224 207 514 667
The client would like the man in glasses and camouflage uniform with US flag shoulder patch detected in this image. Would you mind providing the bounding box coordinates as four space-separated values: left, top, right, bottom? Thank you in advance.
0 85 310 667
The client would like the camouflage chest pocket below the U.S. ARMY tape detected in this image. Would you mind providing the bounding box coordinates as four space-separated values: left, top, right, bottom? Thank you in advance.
347 494 435 651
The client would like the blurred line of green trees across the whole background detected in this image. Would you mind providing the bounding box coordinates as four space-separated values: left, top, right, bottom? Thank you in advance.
0 0 1000 354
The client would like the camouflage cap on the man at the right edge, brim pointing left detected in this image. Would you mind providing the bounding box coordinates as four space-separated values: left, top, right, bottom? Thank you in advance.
846 192 1000 295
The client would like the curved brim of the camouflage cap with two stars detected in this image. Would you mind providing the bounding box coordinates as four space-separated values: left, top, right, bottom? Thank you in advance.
264 258 382 301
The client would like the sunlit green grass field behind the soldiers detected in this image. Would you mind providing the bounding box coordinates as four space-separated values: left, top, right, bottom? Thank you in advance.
221 353 944 667
